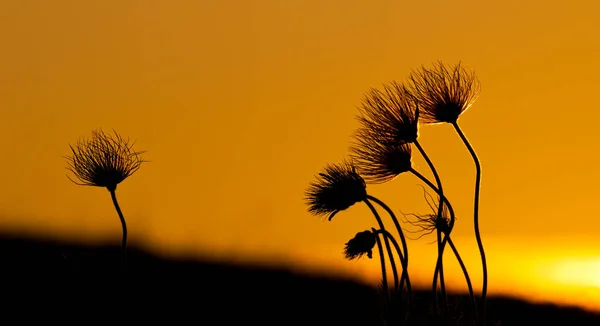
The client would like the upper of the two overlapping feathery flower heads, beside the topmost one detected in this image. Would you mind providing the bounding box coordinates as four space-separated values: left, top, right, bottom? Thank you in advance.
357 81 419 144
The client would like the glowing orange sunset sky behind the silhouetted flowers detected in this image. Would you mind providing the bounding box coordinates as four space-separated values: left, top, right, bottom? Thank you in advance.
0 0 600 309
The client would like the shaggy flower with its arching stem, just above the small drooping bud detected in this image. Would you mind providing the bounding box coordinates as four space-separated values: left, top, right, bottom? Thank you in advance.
305 161 410 298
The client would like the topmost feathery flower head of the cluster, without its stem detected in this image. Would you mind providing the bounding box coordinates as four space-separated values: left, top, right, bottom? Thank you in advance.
407 61 480 123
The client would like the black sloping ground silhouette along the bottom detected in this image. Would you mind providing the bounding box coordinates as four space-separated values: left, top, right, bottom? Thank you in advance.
0 236 600 326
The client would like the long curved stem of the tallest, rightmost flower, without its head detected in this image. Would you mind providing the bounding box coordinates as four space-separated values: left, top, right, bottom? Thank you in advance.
452 121 487 325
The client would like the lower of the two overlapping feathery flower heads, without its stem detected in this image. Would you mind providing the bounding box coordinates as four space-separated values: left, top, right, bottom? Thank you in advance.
350 129 412 183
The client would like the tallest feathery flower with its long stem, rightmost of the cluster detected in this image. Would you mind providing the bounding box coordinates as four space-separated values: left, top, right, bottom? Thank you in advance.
409 61 487 324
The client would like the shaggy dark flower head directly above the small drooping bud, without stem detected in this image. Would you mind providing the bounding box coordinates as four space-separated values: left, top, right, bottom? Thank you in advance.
305 161 367 220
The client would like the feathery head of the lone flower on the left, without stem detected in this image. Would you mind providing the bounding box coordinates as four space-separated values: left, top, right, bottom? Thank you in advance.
65 130 145 191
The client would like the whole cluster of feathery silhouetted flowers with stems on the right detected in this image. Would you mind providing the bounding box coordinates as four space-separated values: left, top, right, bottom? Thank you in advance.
305 61 487 325
